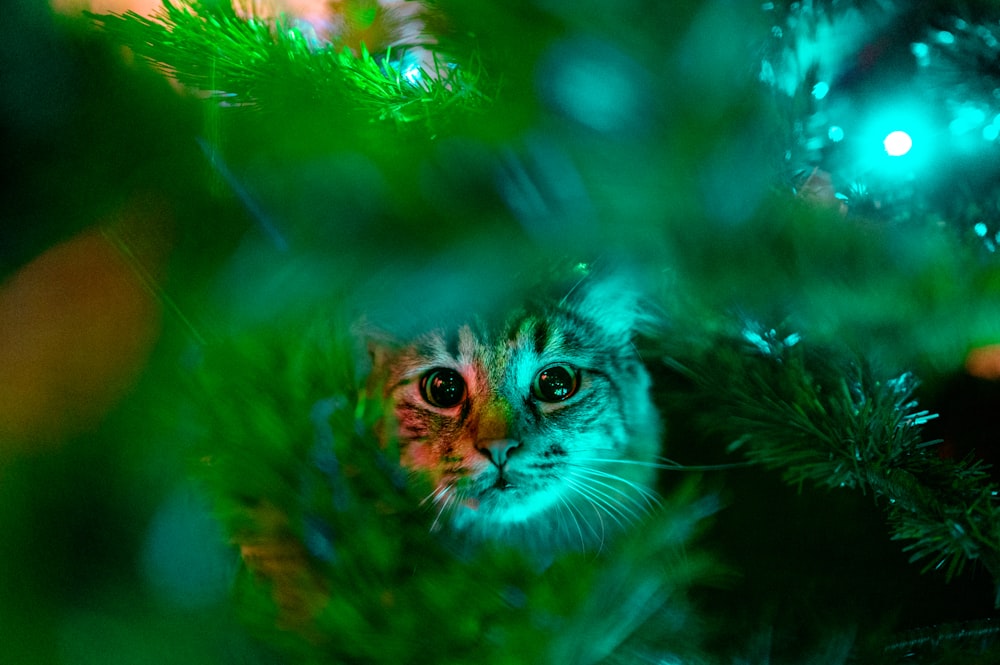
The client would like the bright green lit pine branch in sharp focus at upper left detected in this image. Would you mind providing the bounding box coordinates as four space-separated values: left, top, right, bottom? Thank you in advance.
92 0 491 131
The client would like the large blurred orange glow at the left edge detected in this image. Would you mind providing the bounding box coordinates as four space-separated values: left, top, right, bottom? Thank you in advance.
0 199 166 454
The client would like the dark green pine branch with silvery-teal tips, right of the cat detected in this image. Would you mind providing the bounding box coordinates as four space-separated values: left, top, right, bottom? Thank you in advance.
668 326 1000 606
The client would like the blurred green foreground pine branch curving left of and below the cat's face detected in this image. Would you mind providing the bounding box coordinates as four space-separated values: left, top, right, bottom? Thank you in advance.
184 313 720 665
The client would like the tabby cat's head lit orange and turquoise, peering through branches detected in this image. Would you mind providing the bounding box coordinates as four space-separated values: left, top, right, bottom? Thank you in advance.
372 276 660 546
